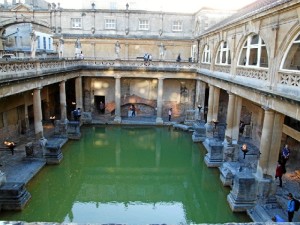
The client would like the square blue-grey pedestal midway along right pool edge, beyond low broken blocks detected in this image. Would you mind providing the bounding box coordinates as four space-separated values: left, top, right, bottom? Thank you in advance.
203 138 223 167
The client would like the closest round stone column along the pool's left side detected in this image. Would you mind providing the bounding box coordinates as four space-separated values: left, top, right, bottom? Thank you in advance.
33 88 44 139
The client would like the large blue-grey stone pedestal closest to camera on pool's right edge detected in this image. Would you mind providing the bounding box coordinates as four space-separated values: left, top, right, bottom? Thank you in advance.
227 171 256 212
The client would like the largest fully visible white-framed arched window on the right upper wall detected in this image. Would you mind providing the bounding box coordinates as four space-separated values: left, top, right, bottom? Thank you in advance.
238 34 268 67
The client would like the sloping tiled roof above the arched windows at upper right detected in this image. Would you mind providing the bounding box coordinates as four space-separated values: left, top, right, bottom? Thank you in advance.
202 0 292 35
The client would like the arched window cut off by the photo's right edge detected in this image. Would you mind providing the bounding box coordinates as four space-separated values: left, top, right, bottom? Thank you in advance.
281 34 300 70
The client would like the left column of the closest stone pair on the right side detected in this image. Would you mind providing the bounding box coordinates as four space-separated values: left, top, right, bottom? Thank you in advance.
256 107 274 178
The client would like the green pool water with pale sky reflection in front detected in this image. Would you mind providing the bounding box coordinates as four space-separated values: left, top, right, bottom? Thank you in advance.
0 126 250 224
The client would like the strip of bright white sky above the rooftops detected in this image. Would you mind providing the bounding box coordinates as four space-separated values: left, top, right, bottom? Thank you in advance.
55 0 254 13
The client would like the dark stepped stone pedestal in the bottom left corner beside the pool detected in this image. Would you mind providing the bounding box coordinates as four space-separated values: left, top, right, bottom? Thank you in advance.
0 182 31 210
